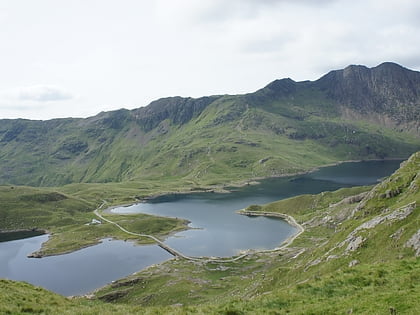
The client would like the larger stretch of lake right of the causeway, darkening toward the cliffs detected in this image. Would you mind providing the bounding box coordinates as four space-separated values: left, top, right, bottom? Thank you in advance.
113 161 401 256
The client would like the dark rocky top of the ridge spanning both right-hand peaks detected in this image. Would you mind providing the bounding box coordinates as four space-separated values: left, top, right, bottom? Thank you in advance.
251 62 420 135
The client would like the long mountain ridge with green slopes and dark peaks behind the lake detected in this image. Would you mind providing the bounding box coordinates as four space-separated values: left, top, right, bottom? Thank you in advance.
0 63 420 186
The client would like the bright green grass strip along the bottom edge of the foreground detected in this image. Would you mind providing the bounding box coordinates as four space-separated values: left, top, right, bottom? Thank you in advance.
0 259 420 314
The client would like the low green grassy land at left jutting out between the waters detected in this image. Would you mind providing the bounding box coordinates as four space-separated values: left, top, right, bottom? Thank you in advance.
0 186 187 256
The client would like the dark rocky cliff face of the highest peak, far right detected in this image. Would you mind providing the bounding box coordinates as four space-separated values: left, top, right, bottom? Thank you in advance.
313 62 420 124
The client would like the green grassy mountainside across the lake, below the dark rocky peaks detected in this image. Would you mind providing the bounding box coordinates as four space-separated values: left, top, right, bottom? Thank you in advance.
0 89 420 186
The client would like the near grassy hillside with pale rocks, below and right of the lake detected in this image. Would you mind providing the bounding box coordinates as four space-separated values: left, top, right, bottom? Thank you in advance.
0 152 420 314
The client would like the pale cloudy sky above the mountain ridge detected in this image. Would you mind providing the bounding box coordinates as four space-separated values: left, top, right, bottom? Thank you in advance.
0 0 420 120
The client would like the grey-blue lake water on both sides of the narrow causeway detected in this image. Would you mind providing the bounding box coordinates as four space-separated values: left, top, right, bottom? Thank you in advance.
0 161 401 295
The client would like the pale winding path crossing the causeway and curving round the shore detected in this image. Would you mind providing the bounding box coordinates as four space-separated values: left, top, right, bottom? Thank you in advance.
93 201 305 263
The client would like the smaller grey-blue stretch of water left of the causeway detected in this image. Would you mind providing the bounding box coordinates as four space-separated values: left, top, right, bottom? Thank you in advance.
0 235 172 296
